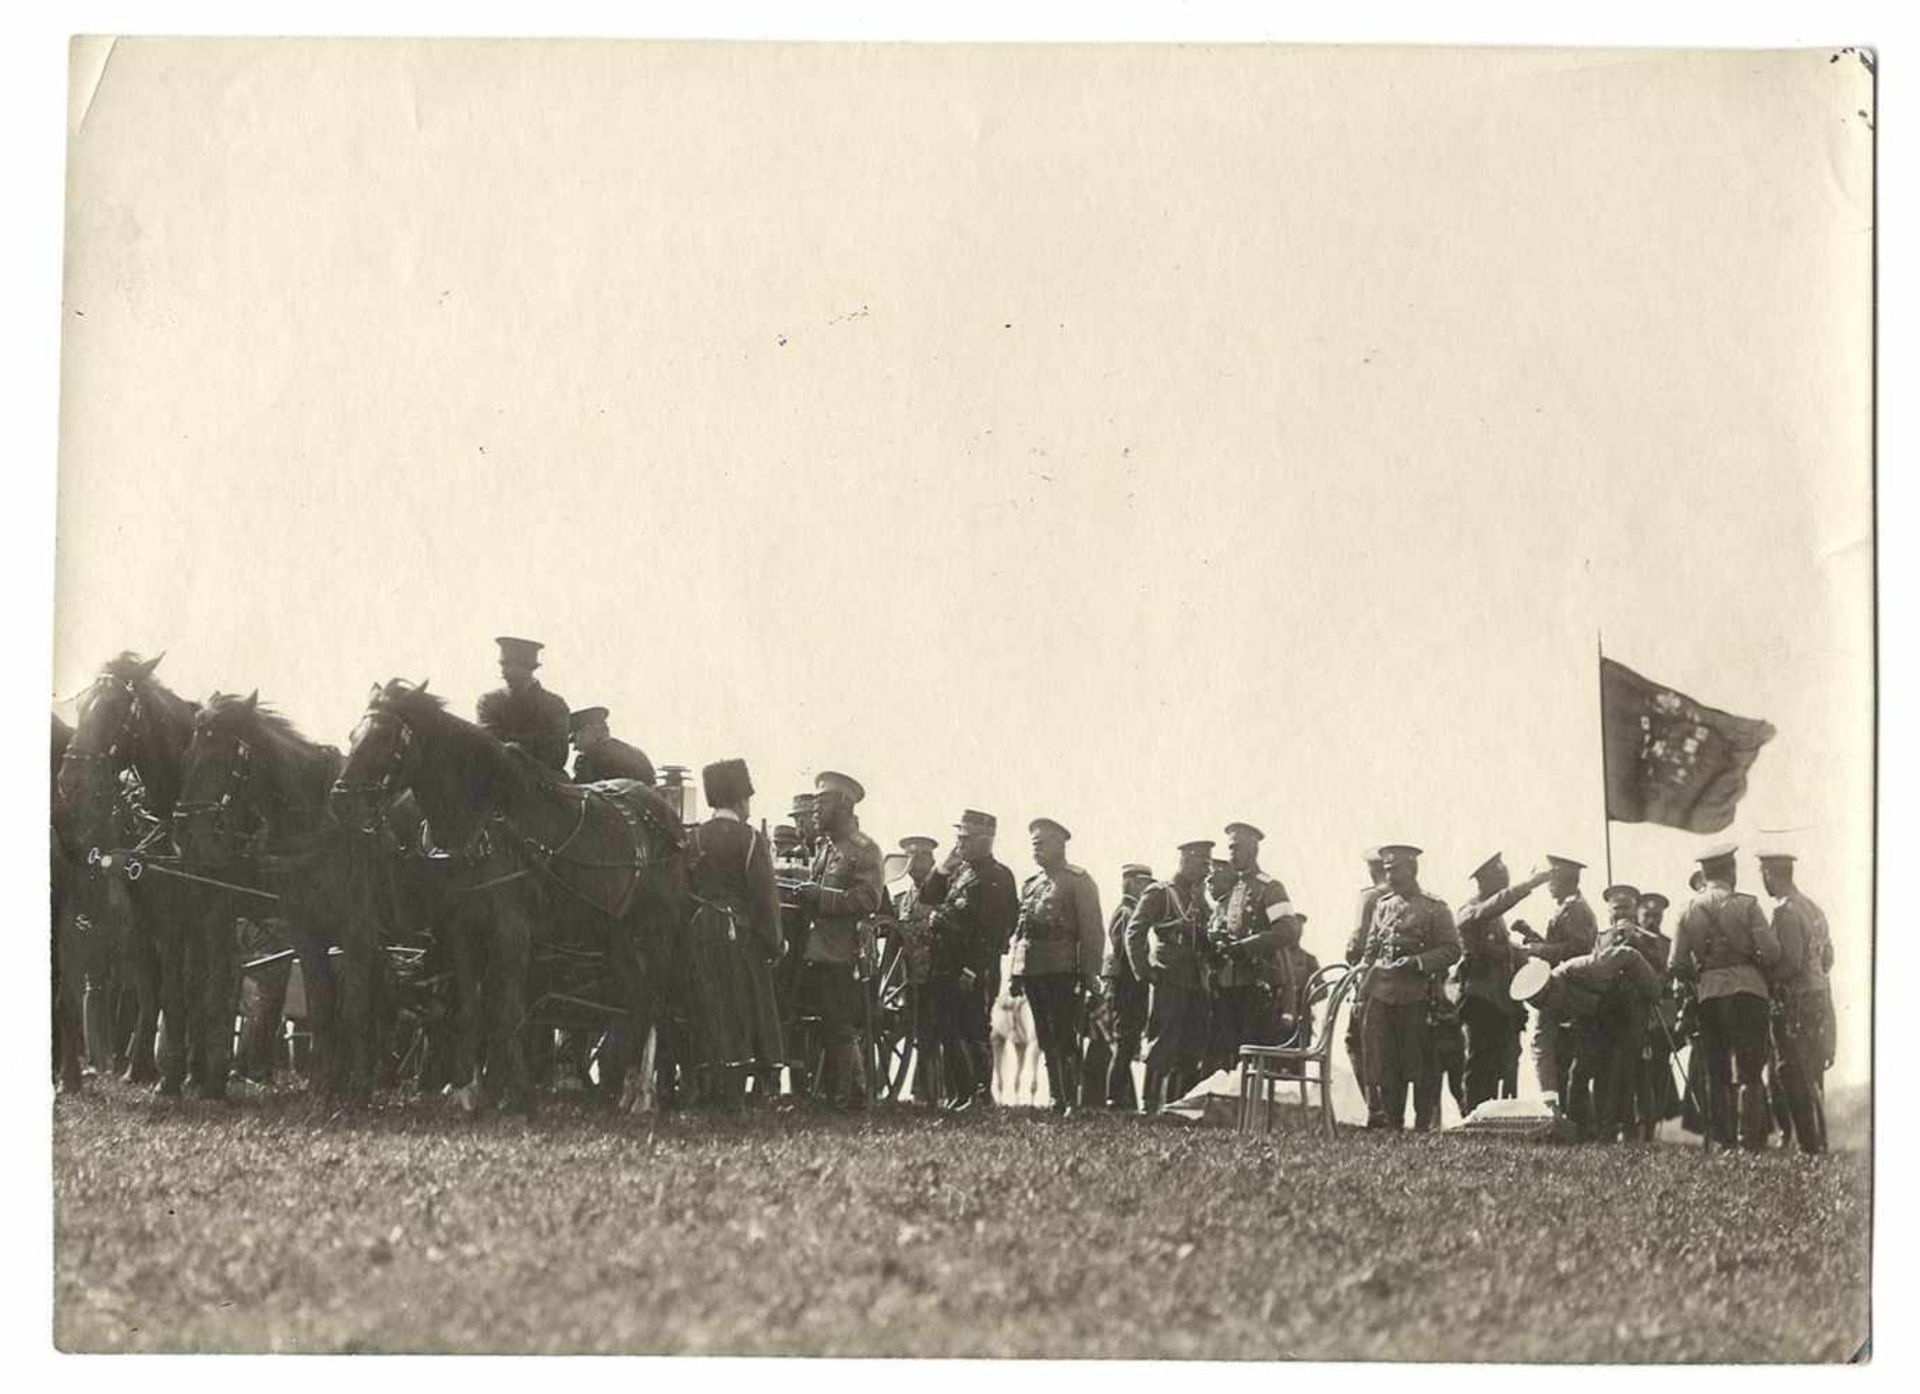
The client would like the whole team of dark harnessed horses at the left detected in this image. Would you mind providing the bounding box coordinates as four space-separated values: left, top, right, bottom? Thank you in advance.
52 653 689 1110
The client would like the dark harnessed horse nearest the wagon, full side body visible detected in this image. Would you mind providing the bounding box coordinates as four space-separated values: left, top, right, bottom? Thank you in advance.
334 678 687 1110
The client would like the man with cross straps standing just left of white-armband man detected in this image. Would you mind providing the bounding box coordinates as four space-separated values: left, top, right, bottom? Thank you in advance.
1127 839 1213 1114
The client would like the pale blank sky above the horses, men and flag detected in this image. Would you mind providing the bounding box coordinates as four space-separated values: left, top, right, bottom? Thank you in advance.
56 40 1872 1077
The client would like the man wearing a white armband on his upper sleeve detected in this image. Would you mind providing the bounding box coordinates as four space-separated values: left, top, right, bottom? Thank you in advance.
1210 822 1300 1062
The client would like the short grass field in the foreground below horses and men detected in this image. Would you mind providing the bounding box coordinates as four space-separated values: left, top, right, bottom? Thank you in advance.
54 1085 1868 1361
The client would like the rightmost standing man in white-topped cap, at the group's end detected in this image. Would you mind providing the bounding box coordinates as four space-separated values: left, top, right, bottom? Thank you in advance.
1761 853 1836 1152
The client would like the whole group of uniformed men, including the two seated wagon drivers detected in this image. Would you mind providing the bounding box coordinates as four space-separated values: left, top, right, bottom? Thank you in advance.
478 637 1836 1152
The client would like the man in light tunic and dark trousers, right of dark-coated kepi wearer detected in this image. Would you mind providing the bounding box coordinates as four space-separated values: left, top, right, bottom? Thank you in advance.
1008 818 1106 1114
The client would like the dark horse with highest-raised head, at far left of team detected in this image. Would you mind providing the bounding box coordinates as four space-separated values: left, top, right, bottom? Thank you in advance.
54 653 212 1094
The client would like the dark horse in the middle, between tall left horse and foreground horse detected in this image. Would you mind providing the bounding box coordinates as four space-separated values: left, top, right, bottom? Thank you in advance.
173 693 424 1096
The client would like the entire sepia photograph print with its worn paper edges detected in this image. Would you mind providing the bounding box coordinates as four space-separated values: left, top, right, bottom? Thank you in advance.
41 33 1873 1379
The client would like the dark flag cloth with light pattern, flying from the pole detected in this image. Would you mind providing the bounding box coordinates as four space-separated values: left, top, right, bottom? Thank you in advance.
1599 659 1774 833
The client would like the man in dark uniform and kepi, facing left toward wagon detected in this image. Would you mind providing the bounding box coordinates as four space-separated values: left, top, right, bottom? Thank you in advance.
920 808 1020 1108
